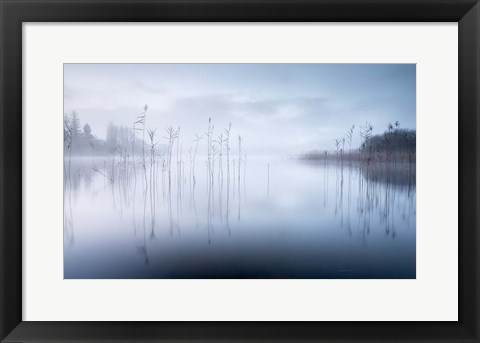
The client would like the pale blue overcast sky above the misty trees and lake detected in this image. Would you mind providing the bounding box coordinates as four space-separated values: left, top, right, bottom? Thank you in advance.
64 64 416 154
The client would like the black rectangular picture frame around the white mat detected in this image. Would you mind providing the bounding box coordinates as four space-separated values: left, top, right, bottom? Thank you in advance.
0 0 480 342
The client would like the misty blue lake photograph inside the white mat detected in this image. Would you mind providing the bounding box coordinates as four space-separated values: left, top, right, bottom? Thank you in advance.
63 63 416 279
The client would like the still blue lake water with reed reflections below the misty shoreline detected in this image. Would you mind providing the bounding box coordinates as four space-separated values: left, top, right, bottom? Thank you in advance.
64 157 416 279
